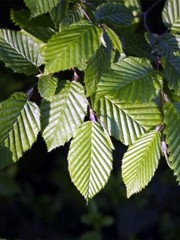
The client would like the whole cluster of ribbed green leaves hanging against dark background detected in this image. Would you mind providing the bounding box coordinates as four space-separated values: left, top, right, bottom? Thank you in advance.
0 0 180 201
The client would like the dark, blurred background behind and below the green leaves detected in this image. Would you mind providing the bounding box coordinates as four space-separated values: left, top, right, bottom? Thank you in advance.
0 0 180 240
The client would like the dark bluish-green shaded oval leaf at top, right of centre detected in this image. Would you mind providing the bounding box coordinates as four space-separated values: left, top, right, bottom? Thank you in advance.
95 2 134 27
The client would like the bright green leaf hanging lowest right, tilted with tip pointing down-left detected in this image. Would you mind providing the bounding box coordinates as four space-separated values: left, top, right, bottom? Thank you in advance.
122 131 161 198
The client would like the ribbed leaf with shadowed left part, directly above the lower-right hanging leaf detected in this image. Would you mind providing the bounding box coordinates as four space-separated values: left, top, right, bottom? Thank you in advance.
94 96 162 145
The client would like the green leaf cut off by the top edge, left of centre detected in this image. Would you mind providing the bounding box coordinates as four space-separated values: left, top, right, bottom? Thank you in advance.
24 0 59 17
